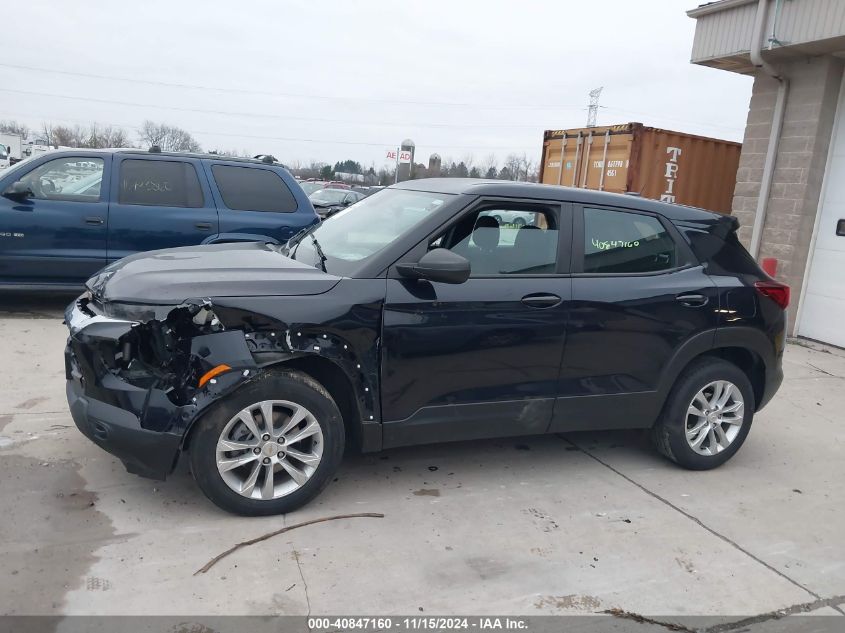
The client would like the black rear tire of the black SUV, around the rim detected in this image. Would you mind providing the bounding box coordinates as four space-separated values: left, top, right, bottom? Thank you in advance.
651 357 755 470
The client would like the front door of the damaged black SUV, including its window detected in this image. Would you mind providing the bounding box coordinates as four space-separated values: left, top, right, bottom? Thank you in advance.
382 200 571 447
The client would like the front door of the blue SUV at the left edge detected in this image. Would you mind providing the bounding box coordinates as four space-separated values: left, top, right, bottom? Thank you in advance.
0 153 112 284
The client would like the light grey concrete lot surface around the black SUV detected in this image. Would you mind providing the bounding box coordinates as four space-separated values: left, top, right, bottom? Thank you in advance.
0 295 845 631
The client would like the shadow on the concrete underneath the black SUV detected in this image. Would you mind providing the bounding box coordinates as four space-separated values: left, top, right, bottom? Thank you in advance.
153 430 660 518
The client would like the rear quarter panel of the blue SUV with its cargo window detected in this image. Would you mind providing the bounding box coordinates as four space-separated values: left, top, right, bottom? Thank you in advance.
206 162 317 243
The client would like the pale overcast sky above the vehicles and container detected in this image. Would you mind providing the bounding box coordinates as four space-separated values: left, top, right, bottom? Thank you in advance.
0 0 751 168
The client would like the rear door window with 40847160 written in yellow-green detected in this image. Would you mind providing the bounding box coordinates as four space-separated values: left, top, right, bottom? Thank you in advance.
583 208 679 274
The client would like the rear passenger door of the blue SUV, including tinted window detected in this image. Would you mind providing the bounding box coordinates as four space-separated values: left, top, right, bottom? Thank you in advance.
108 154 219 262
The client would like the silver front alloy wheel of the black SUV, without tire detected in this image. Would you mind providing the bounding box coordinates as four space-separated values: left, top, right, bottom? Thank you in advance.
216 400 323 501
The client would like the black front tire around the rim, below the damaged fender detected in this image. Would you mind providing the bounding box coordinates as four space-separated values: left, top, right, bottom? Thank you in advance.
189 369 345 516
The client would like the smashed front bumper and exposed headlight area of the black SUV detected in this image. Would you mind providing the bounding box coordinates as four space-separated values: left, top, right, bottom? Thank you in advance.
65 292 268 479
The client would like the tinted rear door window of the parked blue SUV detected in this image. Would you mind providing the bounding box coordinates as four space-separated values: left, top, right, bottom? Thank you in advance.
118 159 204 208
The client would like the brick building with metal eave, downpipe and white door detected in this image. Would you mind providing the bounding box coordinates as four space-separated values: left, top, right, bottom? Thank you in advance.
688 0 845 347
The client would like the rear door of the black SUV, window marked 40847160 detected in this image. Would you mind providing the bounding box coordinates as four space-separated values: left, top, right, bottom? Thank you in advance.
551 205 719 431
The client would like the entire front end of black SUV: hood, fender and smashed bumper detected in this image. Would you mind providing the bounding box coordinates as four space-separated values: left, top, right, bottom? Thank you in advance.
65 238 378 479
